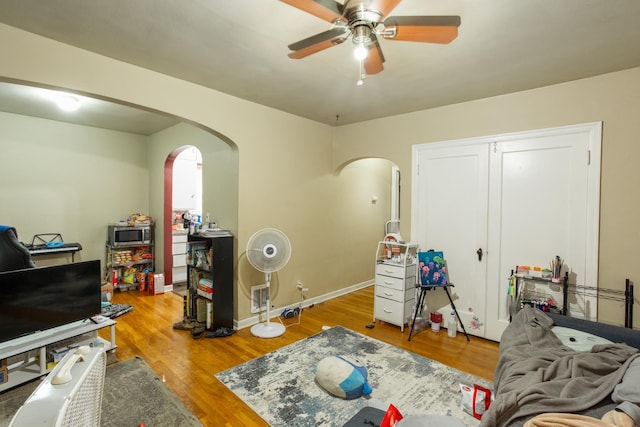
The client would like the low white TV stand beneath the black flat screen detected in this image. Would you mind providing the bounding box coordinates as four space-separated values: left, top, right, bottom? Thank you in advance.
0 319 117 392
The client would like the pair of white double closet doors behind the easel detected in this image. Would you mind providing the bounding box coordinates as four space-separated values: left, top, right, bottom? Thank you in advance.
411 123 601 341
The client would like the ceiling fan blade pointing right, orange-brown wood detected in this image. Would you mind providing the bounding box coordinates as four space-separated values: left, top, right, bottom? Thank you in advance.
383 16 460 44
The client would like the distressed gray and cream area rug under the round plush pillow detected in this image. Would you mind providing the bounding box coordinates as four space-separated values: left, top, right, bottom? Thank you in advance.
216 326 492 426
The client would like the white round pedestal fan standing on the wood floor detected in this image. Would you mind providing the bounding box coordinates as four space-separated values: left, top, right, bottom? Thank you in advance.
247 228 291 338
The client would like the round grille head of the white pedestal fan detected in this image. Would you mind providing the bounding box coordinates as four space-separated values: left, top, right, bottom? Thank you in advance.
247 228 291 273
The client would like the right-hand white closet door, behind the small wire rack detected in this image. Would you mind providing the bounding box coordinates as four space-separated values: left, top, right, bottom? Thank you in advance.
486 126 600 340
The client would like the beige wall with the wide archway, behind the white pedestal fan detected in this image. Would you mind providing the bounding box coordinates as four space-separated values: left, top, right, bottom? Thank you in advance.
0 25 390 326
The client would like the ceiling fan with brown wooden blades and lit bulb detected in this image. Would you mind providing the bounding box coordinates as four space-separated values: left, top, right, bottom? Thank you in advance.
281 0 460 74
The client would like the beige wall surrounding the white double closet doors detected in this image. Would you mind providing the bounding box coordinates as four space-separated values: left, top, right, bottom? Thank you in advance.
335 68 640 325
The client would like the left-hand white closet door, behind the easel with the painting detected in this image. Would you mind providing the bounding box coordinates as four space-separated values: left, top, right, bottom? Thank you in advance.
412 143 489 336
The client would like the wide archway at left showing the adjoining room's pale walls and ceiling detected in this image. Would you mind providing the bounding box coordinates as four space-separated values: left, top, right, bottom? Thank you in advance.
0 79 239 302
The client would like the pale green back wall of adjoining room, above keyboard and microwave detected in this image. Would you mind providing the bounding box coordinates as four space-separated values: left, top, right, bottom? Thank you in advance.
0 113 149 266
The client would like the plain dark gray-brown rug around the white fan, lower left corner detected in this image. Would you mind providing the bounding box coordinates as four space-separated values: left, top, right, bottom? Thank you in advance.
0 357 202 427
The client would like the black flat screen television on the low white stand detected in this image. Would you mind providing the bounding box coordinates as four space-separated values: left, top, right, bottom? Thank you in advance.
0 260 101 342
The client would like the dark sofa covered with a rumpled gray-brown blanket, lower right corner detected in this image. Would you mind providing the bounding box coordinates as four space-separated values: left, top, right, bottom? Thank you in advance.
480 307 640 427
